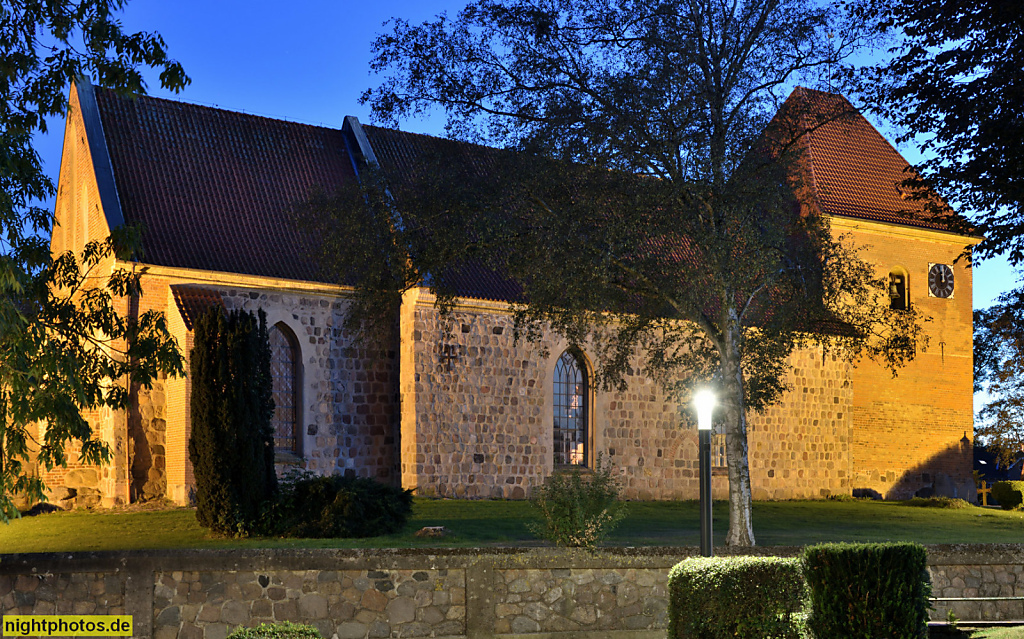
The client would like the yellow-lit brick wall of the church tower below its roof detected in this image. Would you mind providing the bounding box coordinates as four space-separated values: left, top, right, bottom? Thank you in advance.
839 224 974 499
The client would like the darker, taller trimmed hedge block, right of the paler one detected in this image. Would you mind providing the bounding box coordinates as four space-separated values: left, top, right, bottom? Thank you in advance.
803 543 932 639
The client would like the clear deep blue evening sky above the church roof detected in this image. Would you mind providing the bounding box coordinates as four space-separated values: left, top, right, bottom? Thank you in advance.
40 0 1014 308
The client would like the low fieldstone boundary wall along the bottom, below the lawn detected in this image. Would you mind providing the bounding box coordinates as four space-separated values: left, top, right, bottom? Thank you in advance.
0 545 1024 639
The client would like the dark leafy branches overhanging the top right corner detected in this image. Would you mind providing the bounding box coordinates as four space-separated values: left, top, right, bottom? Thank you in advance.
859 0 1024 260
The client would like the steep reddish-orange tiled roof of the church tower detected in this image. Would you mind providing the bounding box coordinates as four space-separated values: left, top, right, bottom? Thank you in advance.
770 87 947 228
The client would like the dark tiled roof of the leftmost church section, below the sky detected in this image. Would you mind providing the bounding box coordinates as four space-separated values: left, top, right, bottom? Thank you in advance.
95 88 354 280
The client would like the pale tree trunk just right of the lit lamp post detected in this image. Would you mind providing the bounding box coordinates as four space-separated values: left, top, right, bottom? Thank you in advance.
721 322 754 546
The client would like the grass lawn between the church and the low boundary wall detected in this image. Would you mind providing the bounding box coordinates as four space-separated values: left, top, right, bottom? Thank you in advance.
0 499 1024 552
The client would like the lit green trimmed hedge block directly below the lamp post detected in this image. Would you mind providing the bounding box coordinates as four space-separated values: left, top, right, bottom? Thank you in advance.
669 557 805 639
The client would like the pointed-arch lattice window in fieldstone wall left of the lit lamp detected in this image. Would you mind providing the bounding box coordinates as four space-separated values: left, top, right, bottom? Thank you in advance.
554 350 590 466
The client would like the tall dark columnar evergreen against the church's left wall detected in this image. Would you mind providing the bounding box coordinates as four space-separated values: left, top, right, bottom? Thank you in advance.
188 308 278 536
